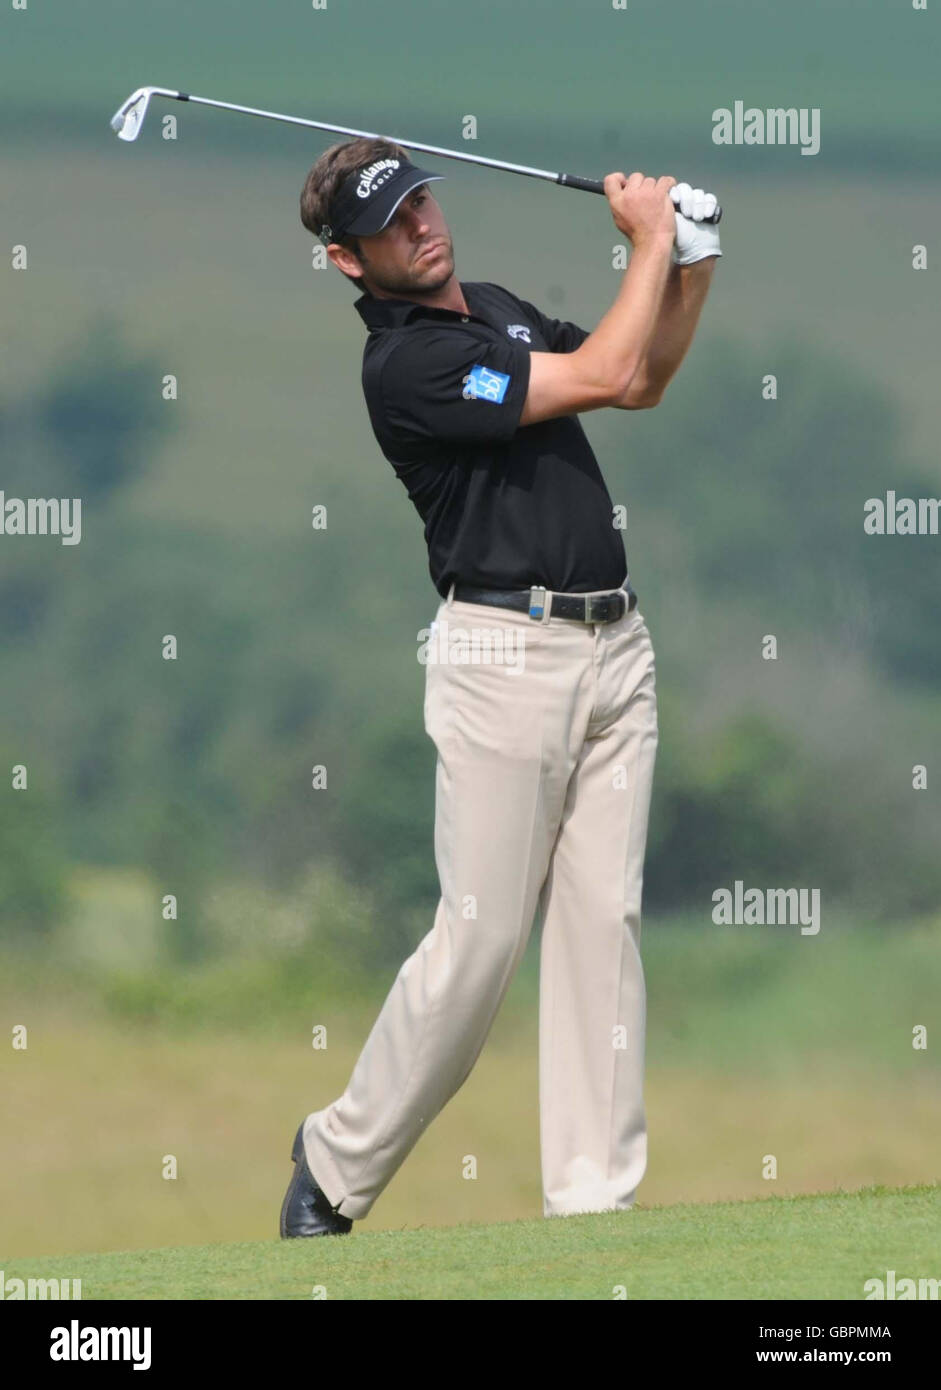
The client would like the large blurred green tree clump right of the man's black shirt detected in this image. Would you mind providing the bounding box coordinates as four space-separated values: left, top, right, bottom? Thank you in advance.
602 342 941 689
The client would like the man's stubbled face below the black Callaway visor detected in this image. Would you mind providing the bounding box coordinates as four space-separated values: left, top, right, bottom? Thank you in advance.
332 183 455 299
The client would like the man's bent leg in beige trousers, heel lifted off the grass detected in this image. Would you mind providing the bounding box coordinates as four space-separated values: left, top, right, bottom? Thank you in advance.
303 603 594 1219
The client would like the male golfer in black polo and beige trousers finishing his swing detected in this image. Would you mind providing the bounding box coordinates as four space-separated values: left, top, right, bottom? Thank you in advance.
281 139 721 1237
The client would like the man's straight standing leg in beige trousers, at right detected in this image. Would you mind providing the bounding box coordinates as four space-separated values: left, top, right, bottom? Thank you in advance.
539 609 657 1216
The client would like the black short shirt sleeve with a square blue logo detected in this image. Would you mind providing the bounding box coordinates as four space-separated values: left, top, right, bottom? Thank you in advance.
379 325 530 443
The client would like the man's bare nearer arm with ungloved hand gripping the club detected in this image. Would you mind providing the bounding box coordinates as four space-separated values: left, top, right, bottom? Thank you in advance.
520 174 676 425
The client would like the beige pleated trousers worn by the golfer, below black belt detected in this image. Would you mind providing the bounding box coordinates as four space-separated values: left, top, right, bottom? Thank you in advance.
303 591 657 1219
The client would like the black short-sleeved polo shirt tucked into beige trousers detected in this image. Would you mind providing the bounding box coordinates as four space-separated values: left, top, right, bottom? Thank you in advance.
356 284 627 595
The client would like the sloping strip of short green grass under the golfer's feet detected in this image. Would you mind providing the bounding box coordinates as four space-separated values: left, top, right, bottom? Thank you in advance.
4 1186 941 1300
